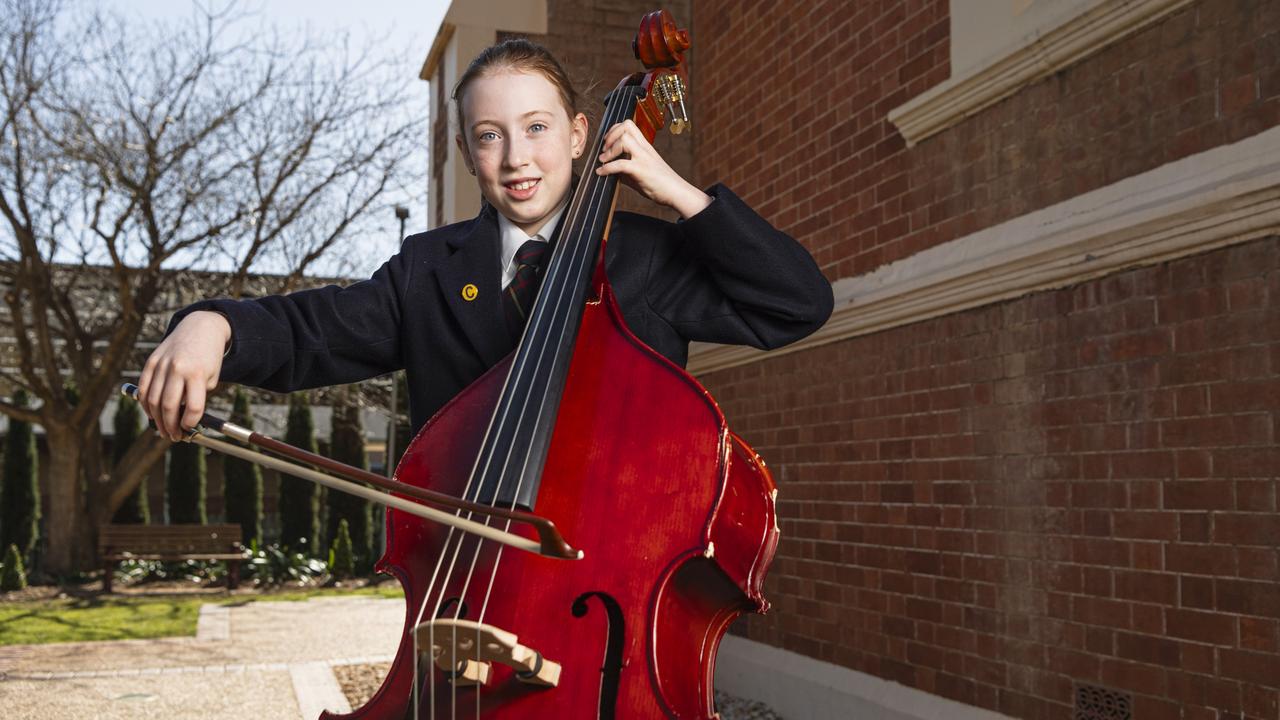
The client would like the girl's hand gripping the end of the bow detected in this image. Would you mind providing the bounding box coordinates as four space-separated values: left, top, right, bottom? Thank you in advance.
138 310 232 442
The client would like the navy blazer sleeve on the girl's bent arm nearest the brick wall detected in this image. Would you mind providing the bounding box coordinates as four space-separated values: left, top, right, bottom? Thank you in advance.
645 184 833 350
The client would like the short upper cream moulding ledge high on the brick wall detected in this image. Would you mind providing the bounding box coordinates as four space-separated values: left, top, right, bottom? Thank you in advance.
888 0 1192 147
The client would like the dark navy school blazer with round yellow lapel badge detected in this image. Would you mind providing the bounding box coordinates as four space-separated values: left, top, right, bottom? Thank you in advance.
169 186 832 433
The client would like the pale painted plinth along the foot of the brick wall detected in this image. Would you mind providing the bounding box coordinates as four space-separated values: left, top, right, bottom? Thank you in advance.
716 635 1010 720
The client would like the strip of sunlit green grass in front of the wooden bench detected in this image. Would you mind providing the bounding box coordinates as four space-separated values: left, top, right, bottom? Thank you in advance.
0 582 404 646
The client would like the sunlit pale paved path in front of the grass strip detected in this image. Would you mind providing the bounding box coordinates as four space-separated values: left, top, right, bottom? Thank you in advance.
0 597 404 720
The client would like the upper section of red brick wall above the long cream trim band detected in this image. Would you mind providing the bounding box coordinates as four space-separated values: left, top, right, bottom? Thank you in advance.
694 0 1280 278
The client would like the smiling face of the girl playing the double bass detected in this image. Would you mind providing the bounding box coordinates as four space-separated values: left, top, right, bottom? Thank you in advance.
456 69 586 236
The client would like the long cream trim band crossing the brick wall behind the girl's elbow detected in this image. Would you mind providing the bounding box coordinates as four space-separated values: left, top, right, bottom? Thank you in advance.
689 127 1280 374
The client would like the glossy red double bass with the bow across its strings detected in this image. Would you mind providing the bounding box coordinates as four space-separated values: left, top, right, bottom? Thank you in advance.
135 10 778 720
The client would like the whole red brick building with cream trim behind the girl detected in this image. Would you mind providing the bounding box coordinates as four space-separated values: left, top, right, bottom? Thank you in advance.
424 0 1280 720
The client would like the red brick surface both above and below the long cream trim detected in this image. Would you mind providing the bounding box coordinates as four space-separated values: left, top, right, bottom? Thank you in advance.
694 0 1280 720
